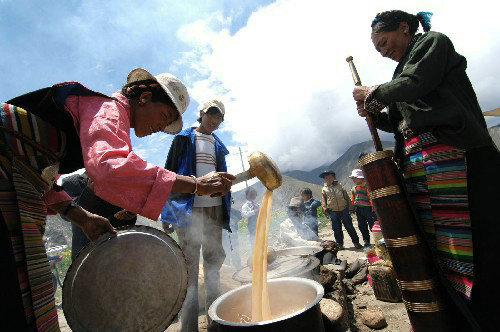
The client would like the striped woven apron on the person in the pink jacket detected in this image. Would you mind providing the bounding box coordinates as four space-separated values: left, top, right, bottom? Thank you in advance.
0 103 66 331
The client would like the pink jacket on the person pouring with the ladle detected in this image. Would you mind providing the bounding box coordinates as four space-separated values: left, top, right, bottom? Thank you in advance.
45 93 177 220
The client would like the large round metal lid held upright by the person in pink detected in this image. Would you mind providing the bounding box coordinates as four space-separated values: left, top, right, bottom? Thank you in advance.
62 226 187 331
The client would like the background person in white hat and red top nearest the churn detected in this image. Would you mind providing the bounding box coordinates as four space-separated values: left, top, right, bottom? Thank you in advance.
349 168 375 247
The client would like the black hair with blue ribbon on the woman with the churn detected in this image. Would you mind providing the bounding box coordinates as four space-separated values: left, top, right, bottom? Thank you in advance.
371 10 432 36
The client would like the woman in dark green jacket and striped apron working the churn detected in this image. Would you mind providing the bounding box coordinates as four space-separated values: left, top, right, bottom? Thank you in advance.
353 10 500 331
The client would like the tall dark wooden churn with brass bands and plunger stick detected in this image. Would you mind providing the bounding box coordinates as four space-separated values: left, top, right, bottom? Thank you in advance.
346 56 455 332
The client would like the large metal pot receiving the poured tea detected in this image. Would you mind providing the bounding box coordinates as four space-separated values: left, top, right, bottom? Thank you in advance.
208 277 324 332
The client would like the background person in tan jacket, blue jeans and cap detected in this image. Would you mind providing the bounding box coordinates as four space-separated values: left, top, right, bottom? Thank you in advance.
319 170 363 250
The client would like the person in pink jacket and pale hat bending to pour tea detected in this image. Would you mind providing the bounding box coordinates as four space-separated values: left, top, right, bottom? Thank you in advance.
0 68 234 331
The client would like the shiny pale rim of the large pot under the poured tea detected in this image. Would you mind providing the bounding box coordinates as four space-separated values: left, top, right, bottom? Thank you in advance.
208 277 325 327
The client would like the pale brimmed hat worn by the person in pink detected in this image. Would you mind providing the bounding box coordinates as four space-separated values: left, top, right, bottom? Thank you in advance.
127 68 189 134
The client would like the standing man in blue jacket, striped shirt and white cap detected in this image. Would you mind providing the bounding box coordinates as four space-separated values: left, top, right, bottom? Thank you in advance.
161 99 231 331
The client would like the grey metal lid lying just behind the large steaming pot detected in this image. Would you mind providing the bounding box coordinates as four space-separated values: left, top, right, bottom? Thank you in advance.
233 256 319 283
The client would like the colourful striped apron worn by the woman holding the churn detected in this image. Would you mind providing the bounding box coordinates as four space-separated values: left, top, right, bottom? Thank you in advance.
403 133 474 299
